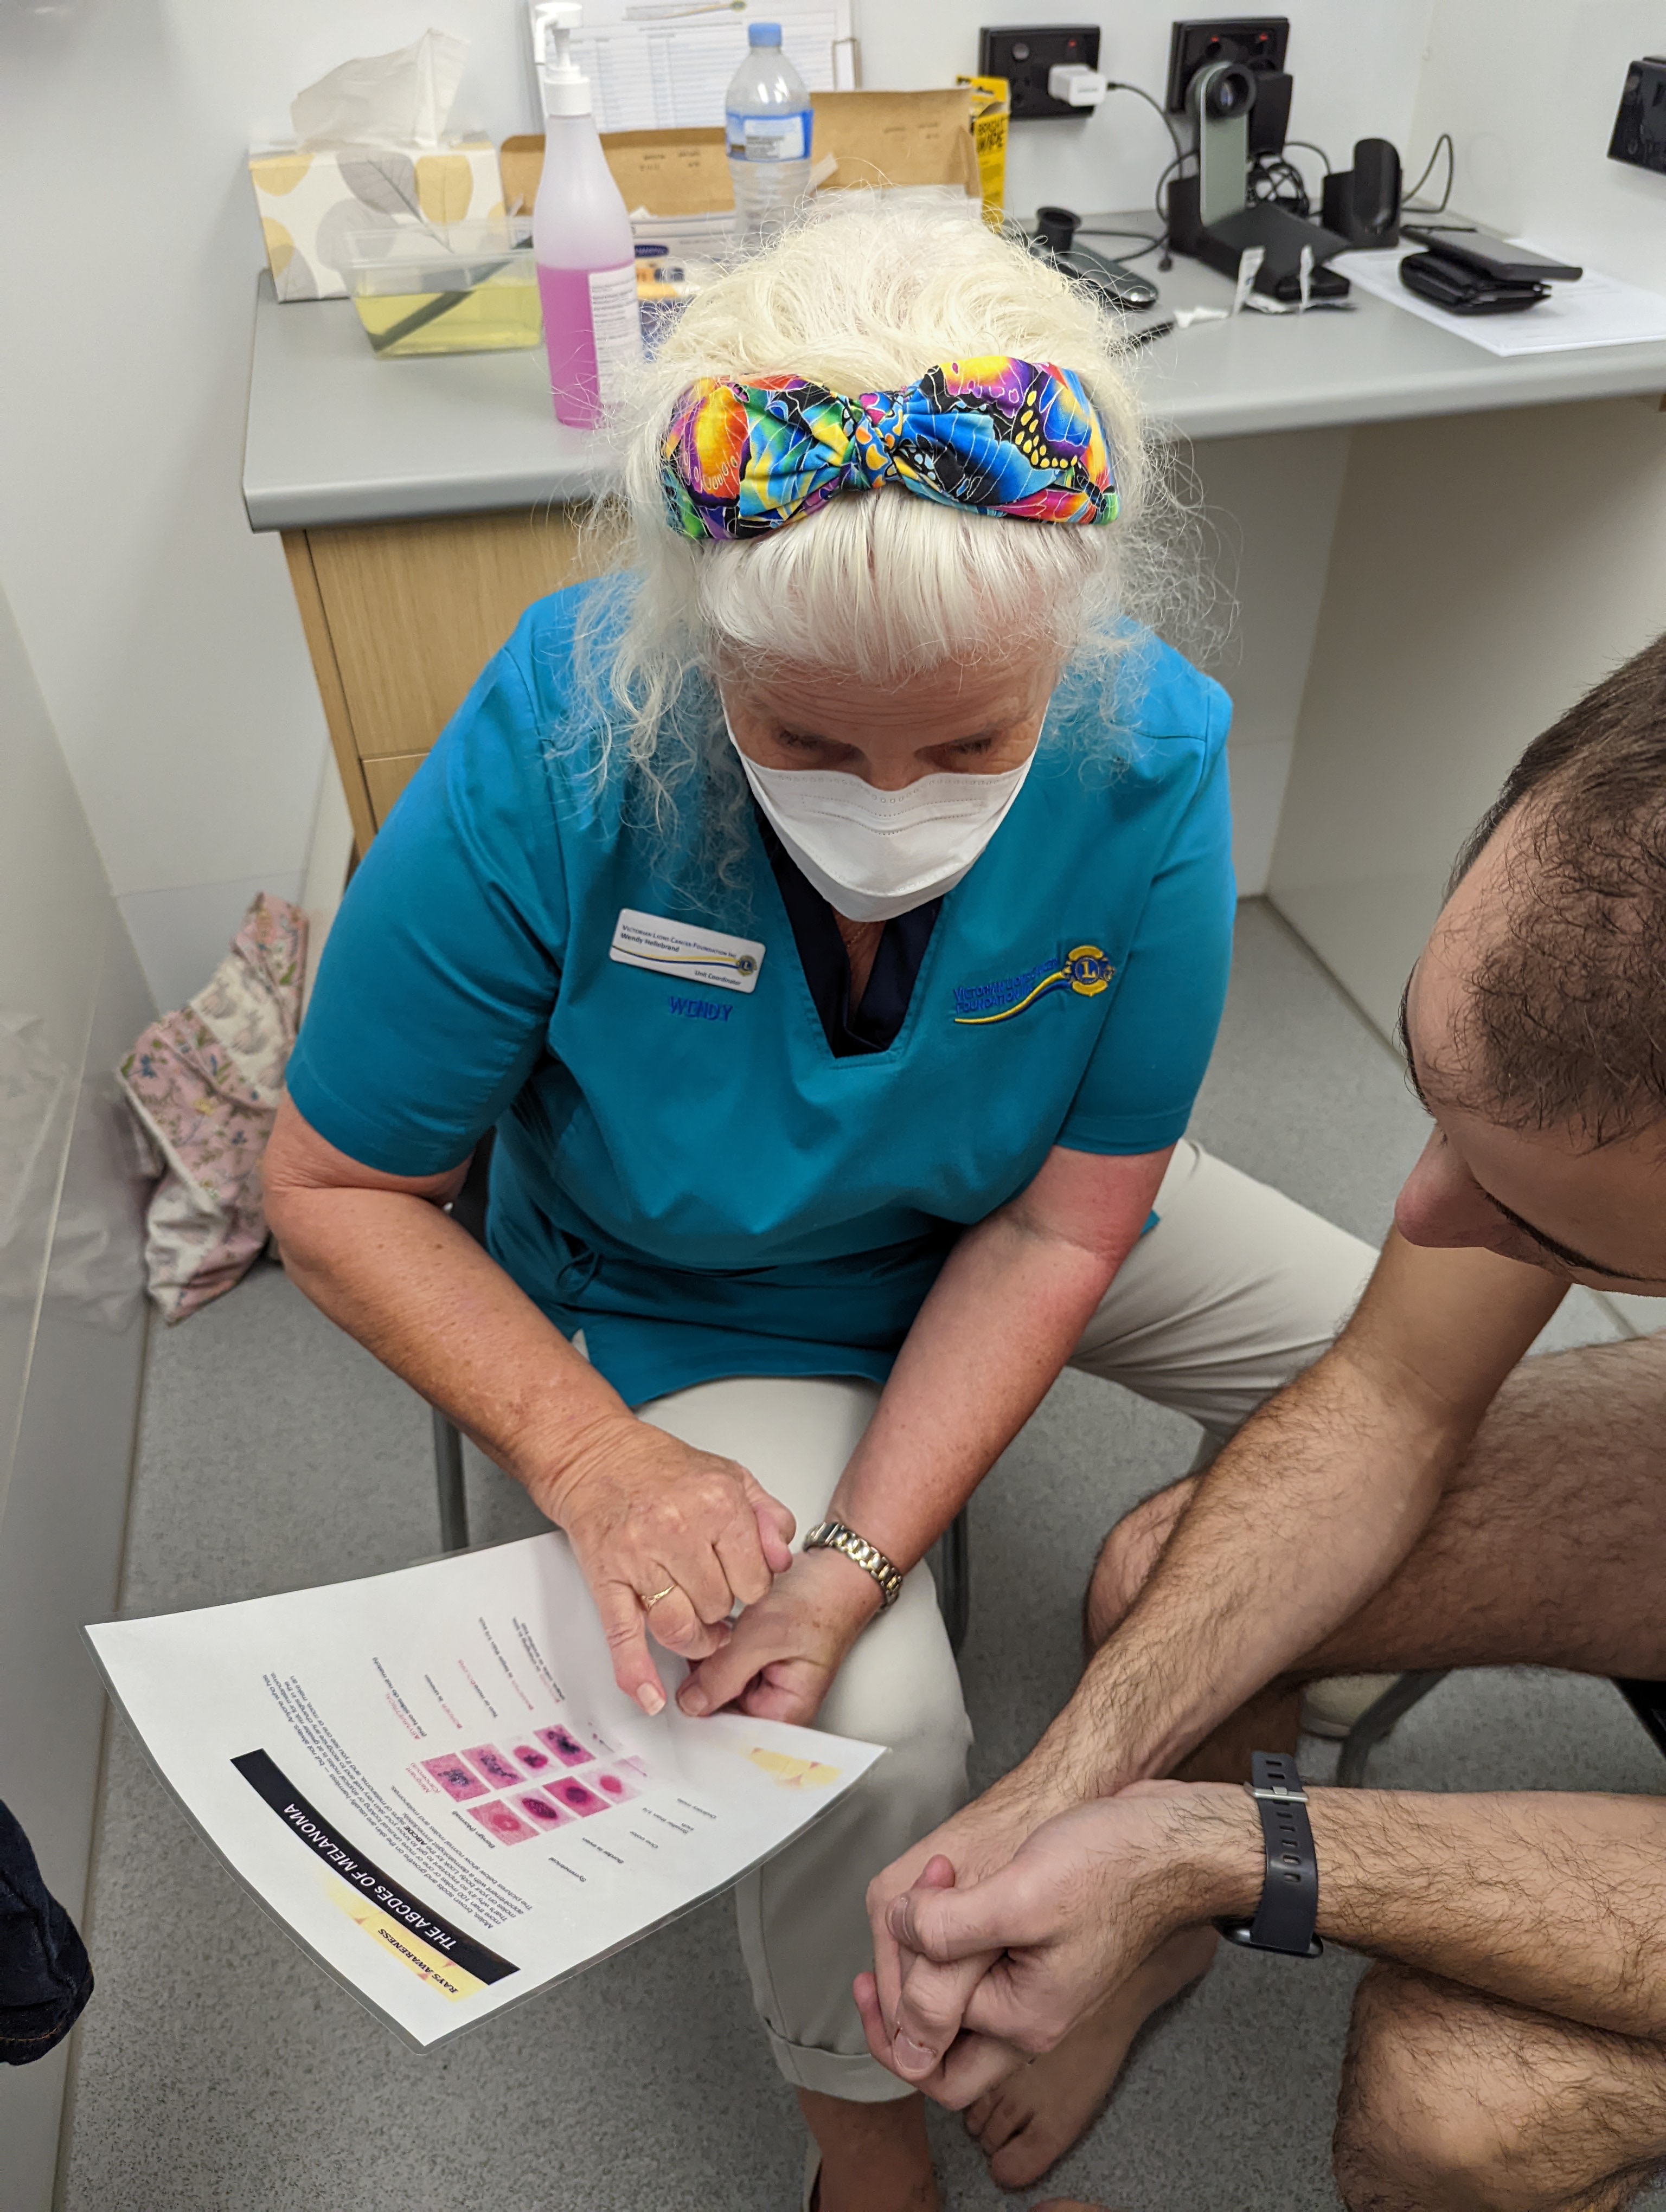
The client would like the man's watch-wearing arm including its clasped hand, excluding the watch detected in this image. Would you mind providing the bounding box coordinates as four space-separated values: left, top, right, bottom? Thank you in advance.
858 1783 1666 2106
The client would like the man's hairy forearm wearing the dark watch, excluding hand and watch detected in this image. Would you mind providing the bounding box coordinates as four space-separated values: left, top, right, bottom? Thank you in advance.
1170 1783 1666 2040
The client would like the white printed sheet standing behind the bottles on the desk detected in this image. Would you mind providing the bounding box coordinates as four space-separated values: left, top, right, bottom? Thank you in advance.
555 0 856 131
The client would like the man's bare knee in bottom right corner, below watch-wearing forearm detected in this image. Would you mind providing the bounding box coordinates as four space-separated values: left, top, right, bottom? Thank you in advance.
1334 1966 1666 2212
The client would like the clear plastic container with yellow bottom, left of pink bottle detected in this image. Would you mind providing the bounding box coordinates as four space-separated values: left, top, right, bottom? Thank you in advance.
341 221 544 361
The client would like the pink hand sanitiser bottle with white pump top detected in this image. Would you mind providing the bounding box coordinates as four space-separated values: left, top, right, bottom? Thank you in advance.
533 0 642 429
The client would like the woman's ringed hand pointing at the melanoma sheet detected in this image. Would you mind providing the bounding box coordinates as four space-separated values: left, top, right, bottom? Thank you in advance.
524 1416 794 1714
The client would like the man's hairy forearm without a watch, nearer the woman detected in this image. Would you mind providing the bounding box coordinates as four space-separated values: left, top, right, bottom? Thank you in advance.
1020 1239 1562 1803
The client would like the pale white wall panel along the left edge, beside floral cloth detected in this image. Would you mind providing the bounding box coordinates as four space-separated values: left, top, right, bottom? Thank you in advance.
0 595 152 2212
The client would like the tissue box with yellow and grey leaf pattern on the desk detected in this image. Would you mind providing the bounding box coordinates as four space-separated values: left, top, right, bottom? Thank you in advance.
248 139 502 299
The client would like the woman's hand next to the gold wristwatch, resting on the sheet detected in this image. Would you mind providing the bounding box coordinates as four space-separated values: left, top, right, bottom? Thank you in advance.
677 1551 879 1725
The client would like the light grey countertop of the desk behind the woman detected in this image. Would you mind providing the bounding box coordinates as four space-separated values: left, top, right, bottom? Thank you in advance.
244 241 1666 531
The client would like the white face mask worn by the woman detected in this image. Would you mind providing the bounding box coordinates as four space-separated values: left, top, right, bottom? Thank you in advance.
723 715 1040 922
